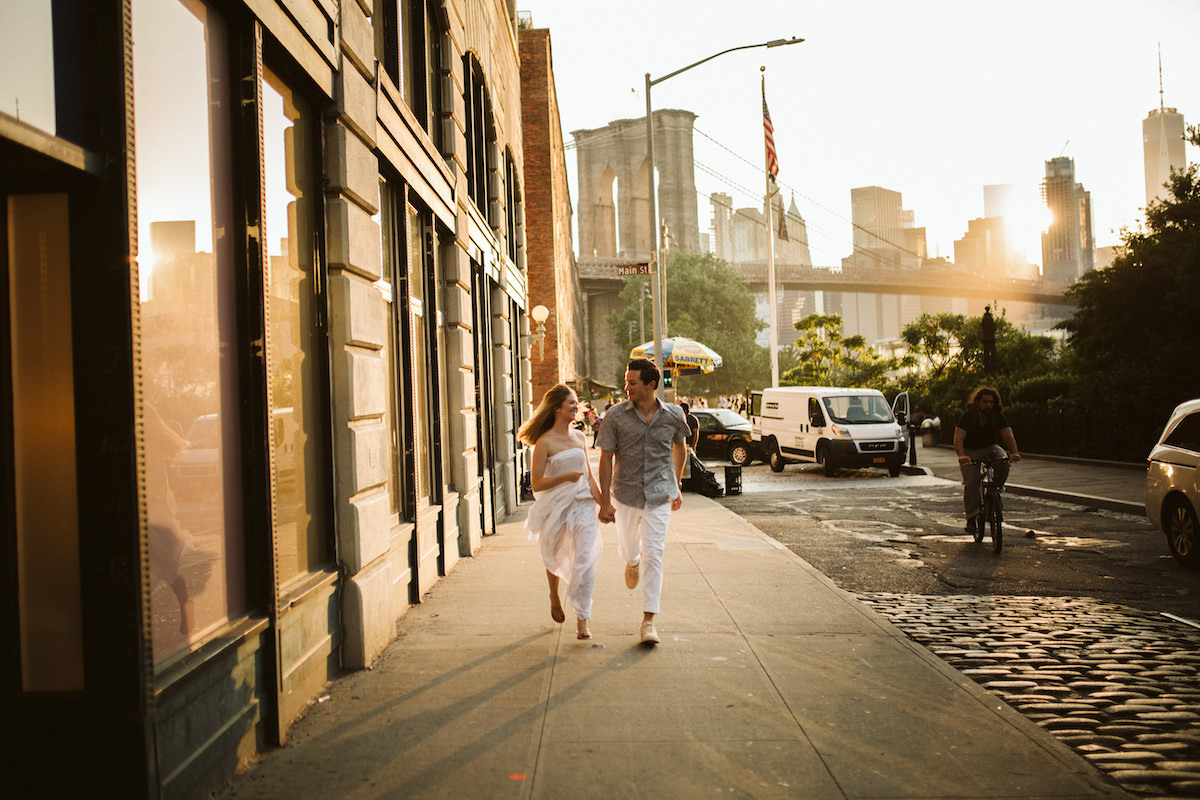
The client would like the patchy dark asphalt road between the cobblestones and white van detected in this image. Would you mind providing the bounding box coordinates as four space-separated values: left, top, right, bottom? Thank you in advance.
709 462 1200 619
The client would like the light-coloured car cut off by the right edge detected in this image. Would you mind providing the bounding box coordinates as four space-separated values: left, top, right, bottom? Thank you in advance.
1146 399 1200 567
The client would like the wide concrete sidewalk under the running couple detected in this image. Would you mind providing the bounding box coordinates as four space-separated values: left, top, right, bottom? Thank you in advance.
222 491 1128 800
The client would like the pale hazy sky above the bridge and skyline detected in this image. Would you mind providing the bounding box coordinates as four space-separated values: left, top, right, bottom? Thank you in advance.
518 0 1200 265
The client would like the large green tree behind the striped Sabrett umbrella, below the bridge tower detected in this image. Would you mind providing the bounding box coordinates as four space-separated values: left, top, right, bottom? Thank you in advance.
605 252 770 393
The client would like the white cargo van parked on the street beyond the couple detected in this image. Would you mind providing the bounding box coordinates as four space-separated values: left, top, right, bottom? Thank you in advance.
750 386 908 477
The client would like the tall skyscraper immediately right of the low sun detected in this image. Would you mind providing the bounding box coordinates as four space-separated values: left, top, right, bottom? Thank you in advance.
1042 156 1096 283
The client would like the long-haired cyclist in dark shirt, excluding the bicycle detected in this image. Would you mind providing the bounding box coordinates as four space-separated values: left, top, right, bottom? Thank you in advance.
954 386 1021 534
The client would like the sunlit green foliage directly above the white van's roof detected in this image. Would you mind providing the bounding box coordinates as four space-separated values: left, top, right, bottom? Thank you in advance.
780 314 904 387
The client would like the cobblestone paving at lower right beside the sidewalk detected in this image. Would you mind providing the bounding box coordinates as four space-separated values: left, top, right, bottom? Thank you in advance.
856 593 1200 798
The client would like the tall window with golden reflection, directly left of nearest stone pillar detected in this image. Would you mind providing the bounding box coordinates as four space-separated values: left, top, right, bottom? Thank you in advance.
262 70 332 584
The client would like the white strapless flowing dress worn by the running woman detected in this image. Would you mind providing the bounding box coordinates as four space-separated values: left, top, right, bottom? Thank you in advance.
526 447 604 619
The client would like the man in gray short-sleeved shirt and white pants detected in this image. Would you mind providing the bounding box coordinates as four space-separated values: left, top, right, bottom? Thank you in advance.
599 359 691 644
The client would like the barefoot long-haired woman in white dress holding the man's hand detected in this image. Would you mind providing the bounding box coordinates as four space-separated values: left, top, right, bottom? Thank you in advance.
517 384 604 639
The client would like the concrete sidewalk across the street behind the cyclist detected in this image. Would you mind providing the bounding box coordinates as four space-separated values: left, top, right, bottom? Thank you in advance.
906 443 1146 516
